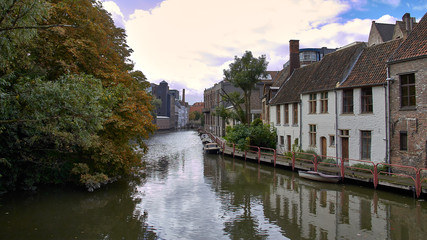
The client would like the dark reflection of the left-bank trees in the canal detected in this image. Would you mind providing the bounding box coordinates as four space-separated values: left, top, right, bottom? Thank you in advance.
0 182 157 240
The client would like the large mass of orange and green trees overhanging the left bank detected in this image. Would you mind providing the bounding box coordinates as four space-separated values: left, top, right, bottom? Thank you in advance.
0 0 155 191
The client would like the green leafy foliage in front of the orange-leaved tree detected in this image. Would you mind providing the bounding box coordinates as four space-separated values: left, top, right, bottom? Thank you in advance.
0 75 116 192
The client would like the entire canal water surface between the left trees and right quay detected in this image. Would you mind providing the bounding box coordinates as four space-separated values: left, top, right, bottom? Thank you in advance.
0 131 427 240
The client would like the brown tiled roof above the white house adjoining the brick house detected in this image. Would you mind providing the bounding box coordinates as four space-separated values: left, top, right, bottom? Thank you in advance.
340 39 402 87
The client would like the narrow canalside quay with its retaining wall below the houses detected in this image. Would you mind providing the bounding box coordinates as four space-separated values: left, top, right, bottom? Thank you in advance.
203 133 427 199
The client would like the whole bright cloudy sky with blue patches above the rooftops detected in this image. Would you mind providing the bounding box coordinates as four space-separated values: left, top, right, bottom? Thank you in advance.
101 0 427 104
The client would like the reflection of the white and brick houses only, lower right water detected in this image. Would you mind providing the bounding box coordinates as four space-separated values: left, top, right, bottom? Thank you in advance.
264 172 427 239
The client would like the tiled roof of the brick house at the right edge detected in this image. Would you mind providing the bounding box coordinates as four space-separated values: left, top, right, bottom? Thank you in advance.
389 13 427 62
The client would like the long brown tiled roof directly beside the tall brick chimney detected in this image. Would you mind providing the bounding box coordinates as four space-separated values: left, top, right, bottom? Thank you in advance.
270 43 366 105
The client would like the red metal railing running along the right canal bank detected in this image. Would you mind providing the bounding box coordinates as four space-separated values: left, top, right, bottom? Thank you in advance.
201 130 427 198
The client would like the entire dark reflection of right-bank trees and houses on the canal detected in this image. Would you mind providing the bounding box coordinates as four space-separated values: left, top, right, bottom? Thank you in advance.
204 156 427 239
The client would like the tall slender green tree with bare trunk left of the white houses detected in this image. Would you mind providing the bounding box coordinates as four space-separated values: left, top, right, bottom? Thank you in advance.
224 51 268 126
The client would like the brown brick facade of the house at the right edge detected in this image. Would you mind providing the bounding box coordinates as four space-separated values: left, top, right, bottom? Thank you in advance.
390 58 427 168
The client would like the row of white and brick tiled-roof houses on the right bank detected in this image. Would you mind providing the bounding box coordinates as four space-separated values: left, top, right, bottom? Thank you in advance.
204 11 427 167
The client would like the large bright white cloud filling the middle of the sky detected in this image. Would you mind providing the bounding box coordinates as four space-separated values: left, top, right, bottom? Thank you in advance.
125 0 350 95
